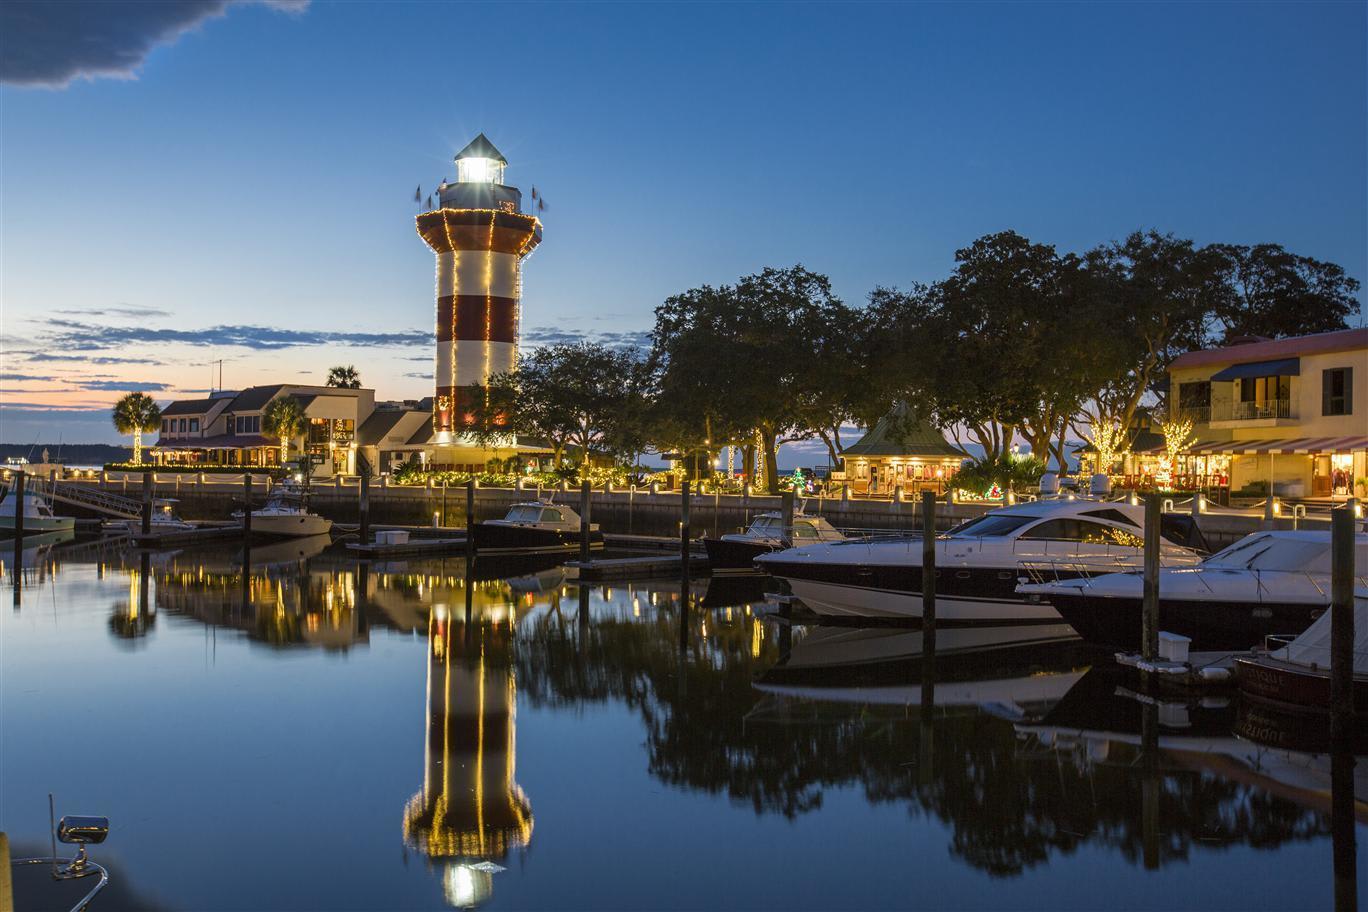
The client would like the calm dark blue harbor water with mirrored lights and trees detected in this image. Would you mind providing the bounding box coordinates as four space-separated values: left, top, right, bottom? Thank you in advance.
0 543 1368 909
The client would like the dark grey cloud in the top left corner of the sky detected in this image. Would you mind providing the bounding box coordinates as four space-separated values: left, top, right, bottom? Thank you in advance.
0 0 308 89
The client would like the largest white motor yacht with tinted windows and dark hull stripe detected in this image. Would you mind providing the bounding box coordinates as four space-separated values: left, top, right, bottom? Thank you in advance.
755 499 1200 629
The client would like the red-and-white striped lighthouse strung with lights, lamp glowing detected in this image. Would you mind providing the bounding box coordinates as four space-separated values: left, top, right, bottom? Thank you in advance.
417 133 542 446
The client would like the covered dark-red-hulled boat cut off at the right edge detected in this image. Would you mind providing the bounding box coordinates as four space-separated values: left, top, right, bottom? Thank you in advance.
1235 587 1368 718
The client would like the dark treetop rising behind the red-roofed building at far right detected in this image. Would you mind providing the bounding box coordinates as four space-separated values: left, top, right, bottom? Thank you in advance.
1205 243 1358 340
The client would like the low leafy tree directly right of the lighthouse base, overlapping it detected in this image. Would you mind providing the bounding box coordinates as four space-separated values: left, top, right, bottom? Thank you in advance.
471 342 644 475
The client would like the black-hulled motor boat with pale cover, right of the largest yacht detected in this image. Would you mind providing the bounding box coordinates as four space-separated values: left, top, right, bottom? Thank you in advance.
1016 531 1368 652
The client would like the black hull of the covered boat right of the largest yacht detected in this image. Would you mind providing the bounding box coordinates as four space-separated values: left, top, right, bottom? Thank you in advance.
1049 592 1326 652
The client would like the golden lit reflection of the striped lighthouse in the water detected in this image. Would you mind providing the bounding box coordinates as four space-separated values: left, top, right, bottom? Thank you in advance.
404 566 534 908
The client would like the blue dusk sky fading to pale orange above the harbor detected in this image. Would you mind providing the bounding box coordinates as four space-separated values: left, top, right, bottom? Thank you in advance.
0 0 1368 443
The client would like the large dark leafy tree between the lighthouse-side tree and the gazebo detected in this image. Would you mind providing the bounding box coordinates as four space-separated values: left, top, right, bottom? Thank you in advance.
651 265 850 491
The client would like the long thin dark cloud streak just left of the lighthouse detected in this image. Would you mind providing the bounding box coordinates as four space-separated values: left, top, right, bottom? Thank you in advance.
44 320 434 351
